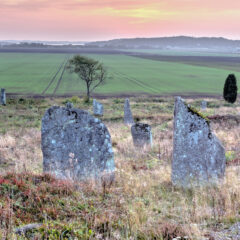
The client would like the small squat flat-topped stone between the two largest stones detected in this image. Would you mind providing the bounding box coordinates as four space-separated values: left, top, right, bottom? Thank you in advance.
131 123 152 147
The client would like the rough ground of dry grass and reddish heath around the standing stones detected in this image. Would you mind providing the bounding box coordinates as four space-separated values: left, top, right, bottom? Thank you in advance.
0 96 240 240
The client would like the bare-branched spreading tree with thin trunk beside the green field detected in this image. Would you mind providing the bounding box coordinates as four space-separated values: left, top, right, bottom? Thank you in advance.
68 55 107 101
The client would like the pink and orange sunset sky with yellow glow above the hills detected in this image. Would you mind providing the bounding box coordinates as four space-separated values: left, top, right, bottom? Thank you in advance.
0 0 240 41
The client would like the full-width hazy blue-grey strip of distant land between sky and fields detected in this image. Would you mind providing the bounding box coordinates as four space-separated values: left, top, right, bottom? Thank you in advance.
0 36 240 53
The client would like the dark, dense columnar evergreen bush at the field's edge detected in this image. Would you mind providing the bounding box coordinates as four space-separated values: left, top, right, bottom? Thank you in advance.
223 74 237 103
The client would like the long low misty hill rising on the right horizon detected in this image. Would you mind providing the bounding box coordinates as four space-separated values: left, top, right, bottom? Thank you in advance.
85 36 240 50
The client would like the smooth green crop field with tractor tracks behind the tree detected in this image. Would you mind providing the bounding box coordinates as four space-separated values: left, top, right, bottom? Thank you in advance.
0 53 240 95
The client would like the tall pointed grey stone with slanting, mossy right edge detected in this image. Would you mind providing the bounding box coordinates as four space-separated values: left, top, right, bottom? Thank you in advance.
172 97 226 187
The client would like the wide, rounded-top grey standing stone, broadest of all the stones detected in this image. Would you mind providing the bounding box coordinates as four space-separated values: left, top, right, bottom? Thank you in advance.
42 106 115 180
